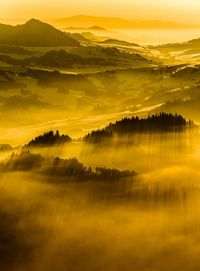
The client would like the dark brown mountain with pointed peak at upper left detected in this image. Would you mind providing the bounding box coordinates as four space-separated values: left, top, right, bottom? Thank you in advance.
0 19 80 47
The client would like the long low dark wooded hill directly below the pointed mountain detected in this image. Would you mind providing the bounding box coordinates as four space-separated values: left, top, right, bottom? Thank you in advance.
0 46 151 68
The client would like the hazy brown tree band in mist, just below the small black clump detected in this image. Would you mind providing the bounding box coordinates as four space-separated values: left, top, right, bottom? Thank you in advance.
0 151 136 181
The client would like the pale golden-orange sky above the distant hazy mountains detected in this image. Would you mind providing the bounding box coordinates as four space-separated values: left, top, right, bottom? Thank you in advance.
0 0 200 23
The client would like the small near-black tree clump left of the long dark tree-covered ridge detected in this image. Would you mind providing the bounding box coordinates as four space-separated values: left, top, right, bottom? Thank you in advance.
25 131 72 147
